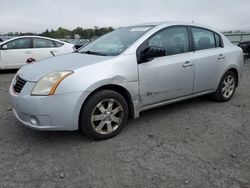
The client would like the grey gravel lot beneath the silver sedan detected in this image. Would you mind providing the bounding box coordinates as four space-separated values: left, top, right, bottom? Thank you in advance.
0 61 250 188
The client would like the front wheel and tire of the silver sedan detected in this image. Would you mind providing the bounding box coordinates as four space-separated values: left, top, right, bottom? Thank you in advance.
79 90 128 140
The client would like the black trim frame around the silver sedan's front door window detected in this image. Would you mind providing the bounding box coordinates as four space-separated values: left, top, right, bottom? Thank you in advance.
136 25 192 64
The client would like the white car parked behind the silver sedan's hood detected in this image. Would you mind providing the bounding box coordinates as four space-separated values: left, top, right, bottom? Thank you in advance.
0 36 75 69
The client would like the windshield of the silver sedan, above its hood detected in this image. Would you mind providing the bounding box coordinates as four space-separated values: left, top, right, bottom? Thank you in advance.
78 26 152 56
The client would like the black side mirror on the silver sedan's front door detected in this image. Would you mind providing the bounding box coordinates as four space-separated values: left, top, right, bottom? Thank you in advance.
140 46 166 62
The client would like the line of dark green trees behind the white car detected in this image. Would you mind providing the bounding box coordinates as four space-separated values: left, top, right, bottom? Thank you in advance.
5 26 114 39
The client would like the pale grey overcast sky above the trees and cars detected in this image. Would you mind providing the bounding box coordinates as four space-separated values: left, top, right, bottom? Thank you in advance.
0 0 250 34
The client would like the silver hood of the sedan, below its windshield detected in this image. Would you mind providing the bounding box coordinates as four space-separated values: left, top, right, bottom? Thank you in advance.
17 53 114 82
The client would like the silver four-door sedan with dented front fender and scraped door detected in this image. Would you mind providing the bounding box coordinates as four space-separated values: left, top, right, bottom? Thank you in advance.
9 22 243 140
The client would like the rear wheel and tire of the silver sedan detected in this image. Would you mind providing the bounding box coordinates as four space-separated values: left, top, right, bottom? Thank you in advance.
213 71 238 102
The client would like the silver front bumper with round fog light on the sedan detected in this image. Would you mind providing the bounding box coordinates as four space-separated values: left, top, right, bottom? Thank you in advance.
9 78 82 130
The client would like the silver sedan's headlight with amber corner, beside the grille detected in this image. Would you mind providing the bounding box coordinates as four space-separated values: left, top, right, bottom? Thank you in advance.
31 71 73 95
